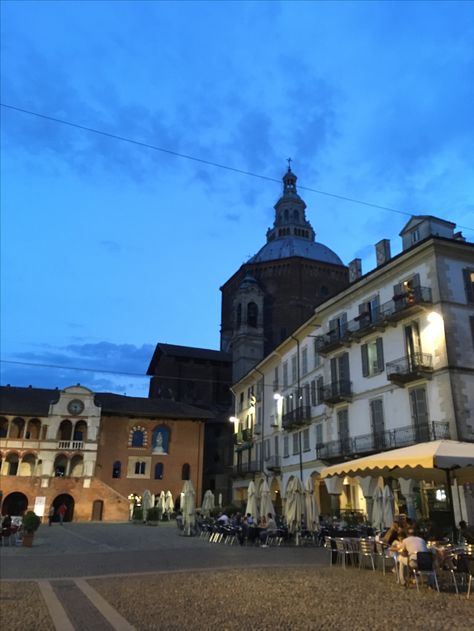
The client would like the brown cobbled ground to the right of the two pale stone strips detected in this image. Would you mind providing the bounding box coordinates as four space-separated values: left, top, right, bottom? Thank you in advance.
89 567 474 631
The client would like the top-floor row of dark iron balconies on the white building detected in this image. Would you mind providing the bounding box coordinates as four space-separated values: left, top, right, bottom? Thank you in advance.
316 287 432 355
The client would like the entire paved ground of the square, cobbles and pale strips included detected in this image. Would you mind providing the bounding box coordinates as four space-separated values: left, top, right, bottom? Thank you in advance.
0 523 474 631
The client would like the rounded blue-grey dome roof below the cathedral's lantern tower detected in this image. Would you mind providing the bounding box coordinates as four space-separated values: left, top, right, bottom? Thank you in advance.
248 237 344 265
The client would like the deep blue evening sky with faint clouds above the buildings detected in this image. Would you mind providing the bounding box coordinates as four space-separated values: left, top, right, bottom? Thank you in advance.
1 1 474 395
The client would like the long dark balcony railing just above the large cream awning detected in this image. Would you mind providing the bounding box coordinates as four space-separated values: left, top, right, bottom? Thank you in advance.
316 421 450 459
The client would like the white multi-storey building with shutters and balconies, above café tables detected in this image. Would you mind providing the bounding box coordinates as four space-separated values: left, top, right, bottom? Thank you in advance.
233 216 474 523
